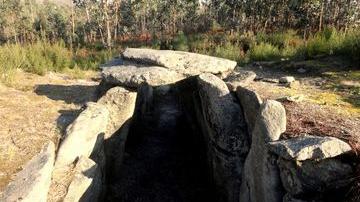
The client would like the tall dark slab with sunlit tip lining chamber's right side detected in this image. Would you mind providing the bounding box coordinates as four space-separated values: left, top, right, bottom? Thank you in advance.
198 74 249 202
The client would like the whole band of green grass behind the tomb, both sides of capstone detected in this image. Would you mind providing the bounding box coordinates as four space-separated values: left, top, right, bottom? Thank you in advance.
0 28 360 83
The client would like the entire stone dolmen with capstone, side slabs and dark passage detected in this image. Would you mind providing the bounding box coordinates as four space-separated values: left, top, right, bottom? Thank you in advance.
0 49 357 202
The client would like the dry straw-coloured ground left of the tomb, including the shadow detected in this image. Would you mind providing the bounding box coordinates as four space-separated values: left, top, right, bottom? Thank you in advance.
0 72 98 192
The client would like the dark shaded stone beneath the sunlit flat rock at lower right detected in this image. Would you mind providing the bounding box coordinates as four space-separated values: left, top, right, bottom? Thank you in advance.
279 159 353 196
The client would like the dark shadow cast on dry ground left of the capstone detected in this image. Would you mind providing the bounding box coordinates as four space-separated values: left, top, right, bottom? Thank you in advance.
35 84 97 104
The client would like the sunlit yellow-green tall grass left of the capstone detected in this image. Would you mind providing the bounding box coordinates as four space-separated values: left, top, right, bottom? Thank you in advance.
0 42 115 84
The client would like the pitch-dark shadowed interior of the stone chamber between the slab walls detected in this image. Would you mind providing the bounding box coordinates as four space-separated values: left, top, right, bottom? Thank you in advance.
105 85 217 202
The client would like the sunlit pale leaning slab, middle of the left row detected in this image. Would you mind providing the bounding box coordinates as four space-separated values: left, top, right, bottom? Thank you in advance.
55 103 109 168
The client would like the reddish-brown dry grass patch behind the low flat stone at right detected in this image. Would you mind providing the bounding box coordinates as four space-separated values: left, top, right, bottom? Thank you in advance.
283 102 360 153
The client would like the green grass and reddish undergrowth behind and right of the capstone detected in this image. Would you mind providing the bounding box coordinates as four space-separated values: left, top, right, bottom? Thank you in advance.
137 28 360 64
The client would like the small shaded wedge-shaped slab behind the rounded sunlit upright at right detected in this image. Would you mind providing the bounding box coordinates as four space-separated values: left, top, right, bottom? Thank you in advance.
236 86 262 137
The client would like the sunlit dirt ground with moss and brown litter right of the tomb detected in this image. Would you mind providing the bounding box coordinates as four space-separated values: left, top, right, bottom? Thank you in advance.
242 61 360 153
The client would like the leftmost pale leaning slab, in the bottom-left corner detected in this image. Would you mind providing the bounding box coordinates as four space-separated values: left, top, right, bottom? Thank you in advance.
0 142 55 202
